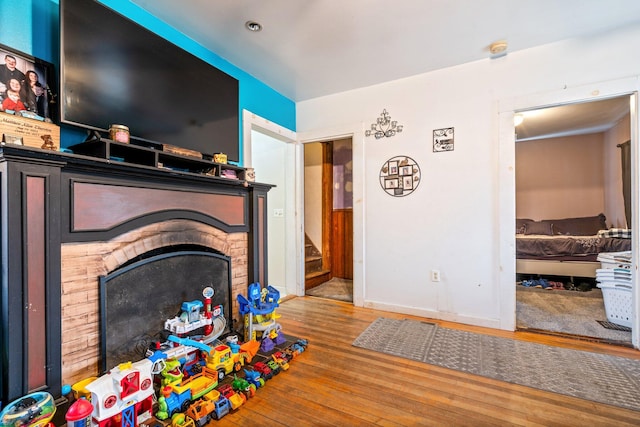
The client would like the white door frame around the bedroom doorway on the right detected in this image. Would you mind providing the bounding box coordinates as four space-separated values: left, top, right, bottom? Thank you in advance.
497 77 640 348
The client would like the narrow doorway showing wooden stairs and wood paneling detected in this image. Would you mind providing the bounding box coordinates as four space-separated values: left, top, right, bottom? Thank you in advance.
303 137 353 302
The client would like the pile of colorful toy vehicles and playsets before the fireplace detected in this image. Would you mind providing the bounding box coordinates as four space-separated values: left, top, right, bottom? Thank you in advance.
0 283 308 427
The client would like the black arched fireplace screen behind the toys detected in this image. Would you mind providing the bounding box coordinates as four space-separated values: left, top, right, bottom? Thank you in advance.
100 251 231 373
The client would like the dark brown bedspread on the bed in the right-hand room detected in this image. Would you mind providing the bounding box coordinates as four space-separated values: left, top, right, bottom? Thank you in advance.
516 235 631 261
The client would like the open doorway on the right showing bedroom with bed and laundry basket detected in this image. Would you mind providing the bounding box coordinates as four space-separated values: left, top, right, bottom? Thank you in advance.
514 96 633 345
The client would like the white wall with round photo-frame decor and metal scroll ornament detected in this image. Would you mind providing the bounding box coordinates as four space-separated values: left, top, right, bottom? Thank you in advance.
297 21 640 328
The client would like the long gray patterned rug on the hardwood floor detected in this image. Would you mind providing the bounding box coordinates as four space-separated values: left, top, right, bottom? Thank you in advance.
353 317 640 411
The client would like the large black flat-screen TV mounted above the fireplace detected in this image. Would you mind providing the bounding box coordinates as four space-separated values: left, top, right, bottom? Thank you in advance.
60 0 240 162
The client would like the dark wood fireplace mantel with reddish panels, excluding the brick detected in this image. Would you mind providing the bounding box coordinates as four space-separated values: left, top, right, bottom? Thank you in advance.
0 145 272 402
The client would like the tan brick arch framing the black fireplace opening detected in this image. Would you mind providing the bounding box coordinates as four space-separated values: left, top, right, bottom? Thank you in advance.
61 219 249 384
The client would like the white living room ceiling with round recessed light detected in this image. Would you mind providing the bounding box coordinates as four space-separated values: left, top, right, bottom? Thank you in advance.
132 0 640 138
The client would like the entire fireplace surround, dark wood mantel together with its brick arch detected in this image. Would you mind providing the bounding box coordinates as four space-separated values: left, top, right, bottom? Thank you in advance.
0 145 272 402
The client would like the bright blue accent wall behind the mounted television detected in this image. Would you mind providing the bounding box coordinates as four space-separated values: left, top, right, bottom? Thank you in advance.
0 0 296 163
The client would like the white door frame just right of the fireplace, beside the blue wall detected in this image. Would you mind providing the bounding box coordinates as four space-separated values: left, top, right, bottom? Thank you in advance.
242 110 304 295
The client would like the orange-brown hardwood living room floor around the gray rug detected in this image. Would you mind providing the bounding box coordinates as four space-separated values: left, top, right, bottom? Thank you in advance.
210 297 640 426
